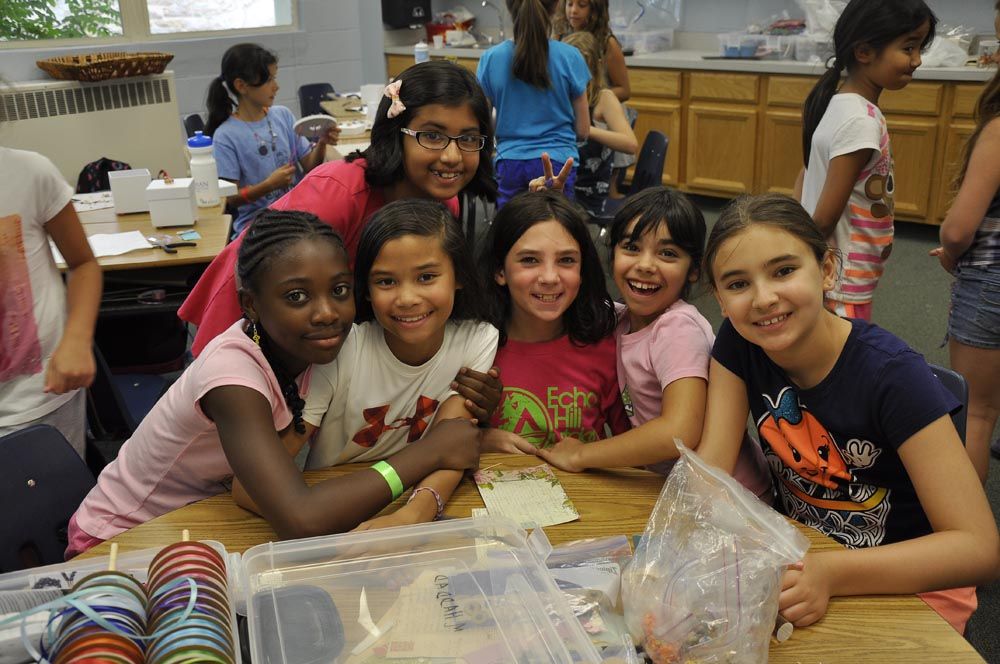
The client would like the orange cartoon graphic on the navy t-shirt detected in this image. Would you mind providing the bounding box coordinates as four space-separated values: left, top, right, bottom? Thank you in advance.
757 386 891 547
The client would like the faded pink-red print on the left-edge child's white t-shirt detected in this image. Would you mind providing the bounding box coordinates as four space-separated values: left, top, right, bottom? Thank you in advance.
0 214 42 382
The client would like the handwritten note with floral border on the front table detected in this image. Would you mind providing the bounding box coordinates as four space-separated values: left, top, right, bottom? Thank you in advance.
475 464 580 528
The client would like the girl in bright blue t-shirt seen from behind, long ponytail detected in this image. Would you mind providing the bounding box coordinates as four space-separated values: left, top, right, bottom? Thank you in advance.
476 0 590 206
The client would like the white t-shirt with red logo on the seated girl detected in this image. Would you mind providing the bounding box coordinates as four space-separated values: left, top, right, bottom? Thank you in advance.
302 321 499 468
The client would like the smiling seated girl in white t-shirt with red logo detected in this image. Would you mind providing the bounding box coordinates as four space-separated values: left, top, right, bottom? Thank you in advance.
296 199 527 527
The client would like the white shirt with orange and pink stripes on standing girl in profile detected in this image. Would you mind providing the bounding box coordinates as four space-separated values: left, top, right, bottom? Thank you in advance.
802 92 896 303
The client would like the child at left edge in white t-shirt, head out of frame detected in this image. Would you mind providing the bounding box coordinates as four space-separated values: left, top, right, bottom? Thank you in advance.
0 147 101 456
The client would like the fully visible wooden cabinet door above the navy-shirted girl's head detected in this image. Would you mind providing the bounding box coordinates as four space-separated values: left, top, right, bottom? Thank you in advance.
685 104 757 194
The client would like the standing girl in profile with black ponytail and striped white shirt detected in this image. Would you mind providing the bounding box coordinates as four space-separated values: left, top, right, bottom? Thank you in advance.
795 0 937 320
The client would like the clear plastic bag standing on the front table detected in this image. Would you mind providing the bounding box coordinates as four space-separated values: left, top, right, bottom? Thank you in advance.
622 441 809 664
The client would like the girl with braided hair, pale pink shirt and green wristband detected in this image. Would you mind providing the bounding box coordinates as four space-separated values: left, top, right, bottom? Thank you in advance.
66 210 479 558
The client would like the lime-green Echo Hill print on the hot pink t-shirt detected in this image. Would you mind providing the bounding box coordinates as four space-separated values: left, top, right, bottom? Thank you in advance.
497 386 601 447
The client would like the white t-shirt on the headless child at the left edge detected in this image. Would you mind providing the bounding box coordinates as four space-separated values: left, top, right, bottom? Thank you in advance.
0 147 76 427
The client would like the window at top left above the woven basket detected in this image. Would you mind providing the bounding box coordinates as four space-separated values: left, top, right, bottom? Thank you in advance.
0 0 294 46
